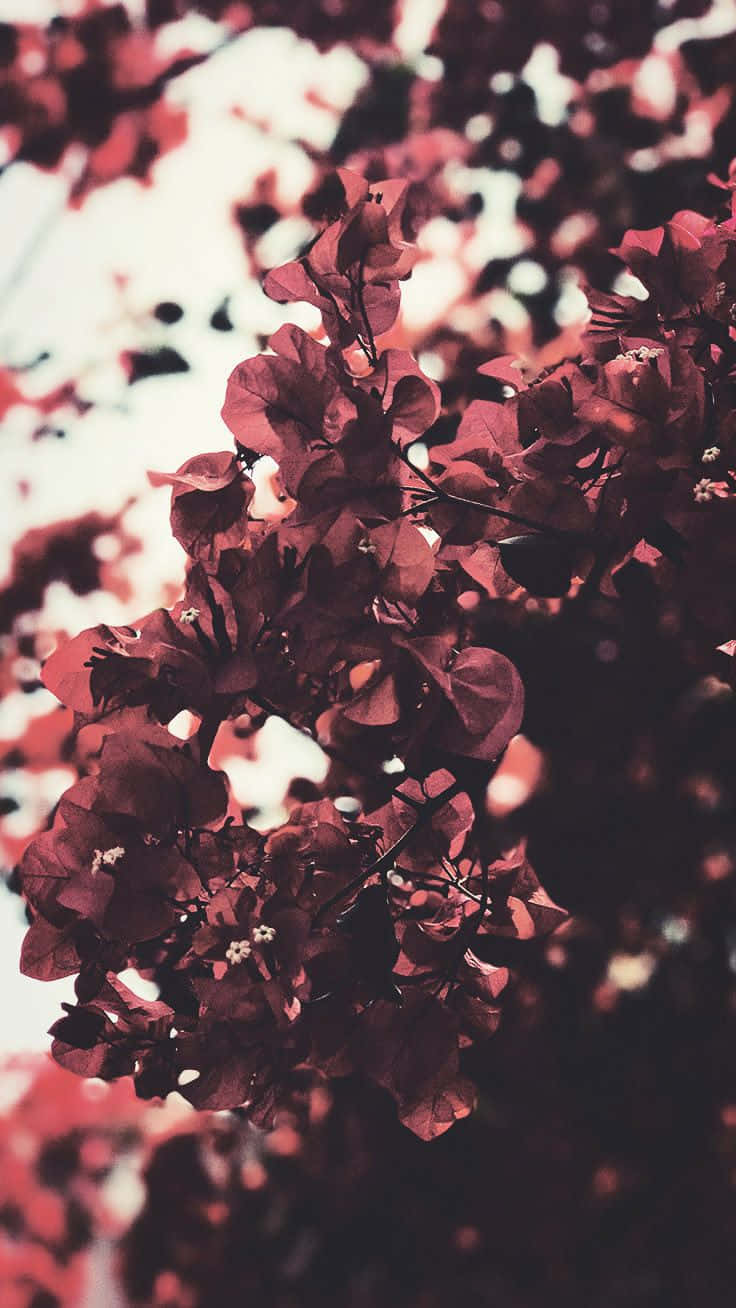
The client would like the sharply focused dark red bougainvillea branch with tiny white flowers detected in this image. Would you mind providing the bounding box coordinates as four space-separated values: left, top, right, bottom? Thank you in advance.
21 170 736 1138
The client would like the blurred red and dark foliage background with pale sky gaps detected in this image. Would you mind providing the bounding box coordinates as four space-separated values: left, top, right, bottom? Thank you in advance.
0 0 736 1308
